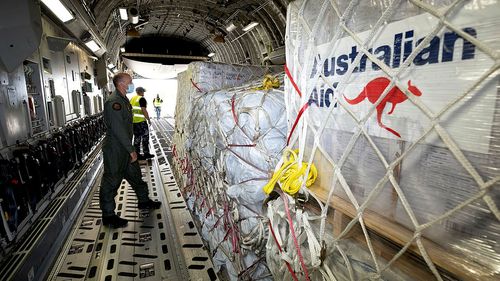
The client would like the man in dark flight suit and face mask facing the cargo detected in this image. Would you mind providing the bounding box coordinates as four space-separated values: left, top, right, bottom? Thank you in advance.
99 73 161 228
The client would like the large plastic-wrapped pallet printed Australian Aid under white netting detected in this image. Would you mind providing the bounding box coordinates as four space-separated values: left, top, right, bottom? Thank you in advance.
267 0 500 280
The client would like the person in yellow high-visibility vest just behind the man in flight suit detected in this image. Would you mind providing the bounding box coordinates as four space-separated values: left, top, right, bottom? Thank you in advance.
130 87 154 160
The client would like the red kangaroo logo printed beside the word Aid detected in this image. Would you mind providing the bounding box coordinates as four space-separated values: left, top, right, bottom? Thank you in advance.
344 77 422 138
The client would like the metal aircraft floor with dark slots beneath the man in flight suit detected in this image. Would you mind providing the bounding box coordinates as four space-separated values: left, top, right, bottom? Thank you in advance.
48 119 218 281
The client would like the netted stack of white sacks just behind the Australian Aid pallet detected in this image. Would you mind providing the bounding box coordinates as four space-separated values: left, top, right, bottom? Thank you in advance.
190 86 287 279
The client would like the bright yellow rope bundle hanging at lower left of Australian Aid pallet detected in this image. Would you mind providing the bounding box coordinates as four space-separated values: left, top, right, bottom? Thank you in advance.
263 149 318 195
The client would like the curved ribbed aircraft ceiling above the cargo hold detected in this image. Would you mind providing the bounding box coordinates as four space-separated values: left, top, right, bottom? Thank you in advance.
53 0 290 67
